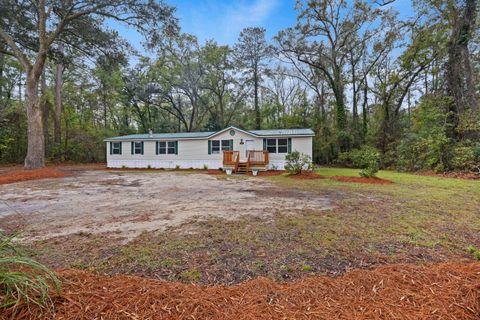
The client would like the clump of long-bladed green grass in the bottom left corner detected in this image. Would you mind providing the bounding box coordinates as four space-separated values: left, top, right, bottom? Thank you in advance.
0 236 60 308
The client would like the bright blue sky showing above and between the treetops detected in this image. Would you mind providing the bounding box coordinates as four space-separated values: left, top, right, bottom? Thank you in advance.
119 0 412 53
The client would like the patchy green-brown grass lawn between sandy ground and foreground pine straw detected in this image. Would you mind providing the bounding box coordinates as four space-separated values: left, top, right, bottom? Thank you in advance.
31 168 480 284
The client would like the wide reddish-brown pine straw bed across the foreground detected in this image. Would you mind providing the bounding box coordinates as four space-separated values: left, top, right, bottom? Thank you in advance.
3 263 480 320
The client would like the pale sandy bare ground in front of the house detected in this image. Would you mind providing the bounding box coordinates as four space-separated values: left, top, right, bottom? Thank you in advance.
0 170 334 240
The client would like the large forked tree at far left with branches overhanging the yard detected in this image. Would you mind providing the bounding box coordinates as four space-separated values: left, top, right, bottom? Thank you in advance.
0 0 176 169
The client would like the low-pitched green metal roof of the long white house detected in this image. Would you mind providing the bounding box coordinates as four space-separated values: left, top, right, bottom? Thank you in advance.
105 127 315 141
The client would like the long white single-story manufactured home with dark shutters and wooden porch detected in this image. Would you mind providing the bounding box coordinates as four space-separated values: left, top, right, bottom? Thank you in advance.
105 127 315 172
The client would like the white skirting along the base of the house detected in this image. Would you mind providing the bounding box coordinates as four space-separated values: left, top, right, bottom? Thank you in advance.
107 159 285 170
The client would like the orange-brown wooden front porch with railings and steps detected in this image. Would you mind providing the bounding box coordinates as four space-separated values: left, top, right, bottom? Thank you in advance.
223 150 269 174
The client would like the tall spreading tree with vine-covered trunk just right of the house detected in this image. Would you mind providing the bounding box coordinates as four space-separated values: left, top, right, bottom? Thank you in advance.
276 0 384 150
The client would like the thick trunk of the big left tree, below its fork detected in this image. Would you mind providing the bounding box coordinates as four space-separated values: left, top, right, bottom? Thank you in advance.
25 70 45 169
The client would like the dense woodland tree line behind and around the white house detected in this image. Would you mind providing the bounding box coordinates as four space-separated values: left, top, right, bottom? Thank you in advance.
0 0 480 171
